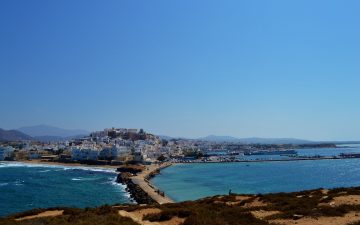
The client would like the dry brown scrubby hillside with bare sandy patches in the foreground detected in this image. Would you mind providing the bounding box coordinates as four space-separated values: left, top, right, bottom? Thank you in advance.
0 188 360 225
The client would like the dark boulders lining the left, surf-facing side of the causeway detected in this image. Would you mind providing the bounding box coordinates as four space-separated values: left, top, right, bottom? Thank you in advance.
116 172 157 205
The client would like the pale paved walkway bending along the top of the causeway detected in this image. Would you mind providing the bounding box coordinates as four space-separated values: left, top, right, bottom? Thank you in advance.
131 163 174 204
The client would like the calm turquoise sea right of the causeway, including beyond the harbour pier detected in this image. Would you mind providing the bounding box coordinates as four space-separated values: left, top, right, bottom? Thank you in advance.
151 145 360 202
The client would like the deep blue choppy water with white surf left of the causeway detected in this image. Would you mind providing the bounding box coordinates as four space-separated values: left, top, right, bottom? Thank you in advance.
0 162 131 217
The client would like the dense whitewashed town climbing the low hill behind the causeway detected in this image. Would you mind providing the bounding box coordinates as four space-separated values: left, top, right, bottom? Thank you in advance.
0 128 199 165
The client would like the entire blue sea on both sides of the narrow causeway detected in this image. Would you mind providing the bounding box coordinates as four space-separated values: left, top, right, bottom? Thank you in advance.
0 145 360 217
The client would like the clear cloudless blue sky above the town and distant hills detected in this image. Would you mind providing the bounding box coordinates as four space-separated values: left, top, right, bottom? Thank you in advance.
0 0 360 140
